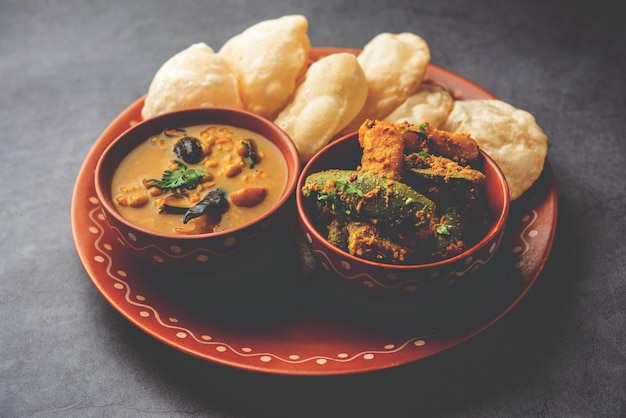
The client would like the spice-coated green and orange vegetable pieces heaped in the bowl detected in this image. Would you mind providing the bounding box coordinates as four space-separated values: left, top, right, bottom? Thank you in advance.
300 120 488 264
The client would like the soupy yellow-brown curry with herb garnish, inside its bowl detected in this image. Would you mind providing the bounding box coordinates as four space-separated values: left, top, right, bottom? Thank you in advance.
111 124 287 234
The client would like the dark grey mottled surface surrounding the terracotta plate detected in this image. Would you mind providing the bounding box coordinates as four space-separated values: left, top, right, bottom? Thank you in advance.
0 0 626 417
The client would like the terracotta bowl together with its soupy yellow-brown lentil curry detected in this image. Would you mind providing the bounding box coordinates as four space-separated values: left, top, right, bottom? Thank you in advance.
95 108 301 273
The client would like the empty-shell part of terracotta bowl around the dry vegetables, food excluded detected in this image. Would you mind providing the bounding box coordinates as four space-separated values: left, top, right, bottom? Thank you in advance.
296 133 510 300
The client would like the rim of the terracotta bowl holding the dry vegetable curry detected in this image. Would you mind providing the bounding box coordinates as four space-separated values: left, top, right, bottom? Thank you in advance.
296 132 511 271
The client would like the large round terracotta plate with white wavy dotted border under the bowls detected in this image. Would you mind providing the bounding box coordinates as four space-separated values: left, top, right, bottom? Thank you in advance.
72 48 557 375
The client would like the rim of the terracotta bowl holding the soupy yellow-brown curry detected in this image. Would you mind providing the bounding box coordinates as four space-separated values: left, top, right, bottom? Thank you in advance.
93 106 302 241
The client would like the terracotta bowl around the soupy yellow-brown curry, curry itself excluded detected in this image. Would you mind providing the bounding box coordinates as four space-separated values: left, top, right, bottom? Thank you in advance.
95 108 301 273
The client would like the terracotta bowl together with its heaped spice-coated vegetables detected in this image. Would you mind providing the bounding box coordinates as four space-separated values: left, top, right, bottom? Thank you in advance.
296 120 510 300
